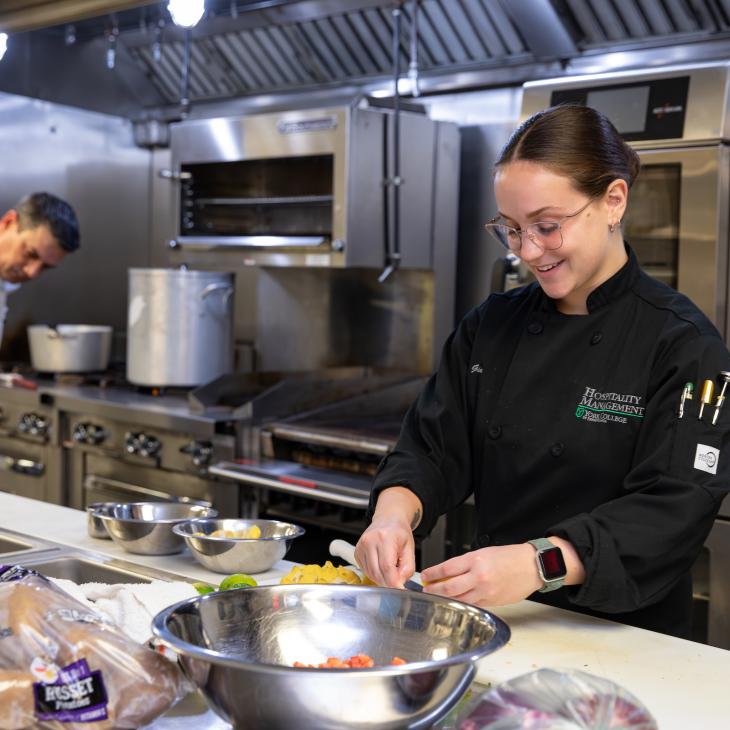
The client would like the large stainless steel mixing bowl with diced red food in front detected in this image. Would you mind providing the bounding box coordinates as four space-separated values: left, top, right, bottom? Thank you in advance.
152 584 510 730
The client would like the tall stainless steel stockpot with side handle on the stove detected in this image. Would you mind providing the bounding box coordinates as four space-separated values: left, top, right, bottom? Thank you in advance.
127 269 233 387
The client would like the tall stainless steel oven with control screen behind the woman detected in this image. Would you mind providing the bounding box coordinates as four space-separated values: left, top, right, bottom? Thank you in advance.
521 63 730 649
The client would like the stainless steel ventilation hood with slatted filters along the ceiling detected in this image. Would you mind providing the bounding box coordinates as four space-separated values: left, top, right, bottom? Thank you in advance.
0 0 730 117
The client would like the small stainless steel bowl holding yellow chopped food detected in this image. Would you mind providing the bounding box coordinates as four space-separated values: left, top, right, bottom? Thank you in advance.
172 519 304 574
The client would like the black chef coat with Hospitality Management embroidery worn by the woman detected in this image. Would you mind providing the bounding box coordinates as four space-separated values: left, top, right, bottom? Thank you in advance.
371 247 730 636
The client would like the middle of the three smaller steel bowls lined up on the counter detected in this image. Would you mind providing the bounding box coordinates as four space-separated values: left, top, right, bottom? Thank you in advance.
96 502 218 555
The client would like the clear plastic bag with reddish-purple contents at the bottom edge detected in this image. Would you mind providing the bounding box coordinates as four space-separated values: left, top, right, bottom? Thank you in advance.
457 669 657 730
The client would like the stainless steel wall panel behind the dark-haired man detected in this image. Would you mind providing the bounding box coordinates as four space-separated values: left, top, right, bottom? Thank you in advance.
0 94 150 360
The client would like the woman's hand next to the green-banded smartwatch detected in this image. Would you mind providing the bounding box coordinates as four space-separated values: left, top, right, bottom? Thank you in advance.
421 543 543 606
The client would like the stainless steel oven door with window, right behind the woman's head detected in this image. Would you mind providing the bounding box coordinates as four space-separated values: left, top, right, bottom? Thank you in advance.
624 145 730 337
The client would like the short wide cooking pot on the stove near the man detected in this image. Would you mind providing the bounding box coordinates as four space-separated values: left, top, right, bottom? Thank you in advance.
28 324 112 373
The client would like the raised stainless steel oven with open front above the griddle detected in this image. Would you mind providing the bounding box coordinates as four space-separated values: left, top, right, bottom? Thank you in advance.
164 100 459 270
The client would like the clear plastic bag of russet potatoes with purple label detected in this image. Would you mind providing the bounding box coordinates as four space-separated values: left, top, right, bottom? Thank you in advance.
0 566 191 730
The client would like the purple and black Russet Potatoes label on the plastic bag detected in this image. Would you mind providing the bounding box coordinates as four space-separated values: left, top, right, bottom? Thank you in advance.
33 659 109 722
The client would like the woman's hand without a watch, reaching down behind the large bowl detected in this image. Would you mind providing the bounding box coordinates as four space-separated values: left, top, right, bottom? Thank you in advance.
355 487 422 588
